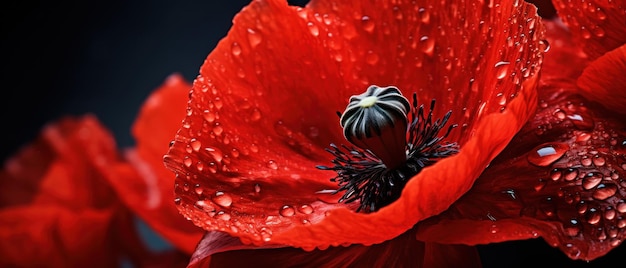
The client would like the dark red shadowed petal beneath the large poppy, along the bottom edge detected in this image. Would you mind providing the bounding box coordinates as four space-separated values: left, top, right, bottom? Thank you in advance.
188 228 480 267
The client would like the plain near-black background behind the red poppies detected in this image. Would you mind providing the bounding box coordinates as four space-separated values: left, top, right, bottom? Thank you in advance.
0 0 625 267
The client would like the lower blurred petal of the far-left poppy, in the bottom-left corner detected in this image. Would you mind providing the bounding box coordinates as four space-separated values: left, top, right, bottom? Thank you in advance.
0 204 118 267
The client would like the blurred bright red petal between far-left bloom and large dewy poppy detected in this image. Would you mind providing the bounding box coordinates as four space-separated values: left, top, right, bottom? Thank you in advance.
107 74 204 254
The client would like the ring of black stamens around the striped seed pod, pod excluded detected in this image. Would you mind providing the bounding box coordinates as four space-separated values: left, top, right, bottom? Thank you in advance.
317 94 459 212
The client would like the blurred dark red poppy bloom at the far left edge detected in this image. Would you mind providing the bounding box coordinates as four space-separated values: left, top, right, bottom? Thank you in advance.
0 116 121 267
